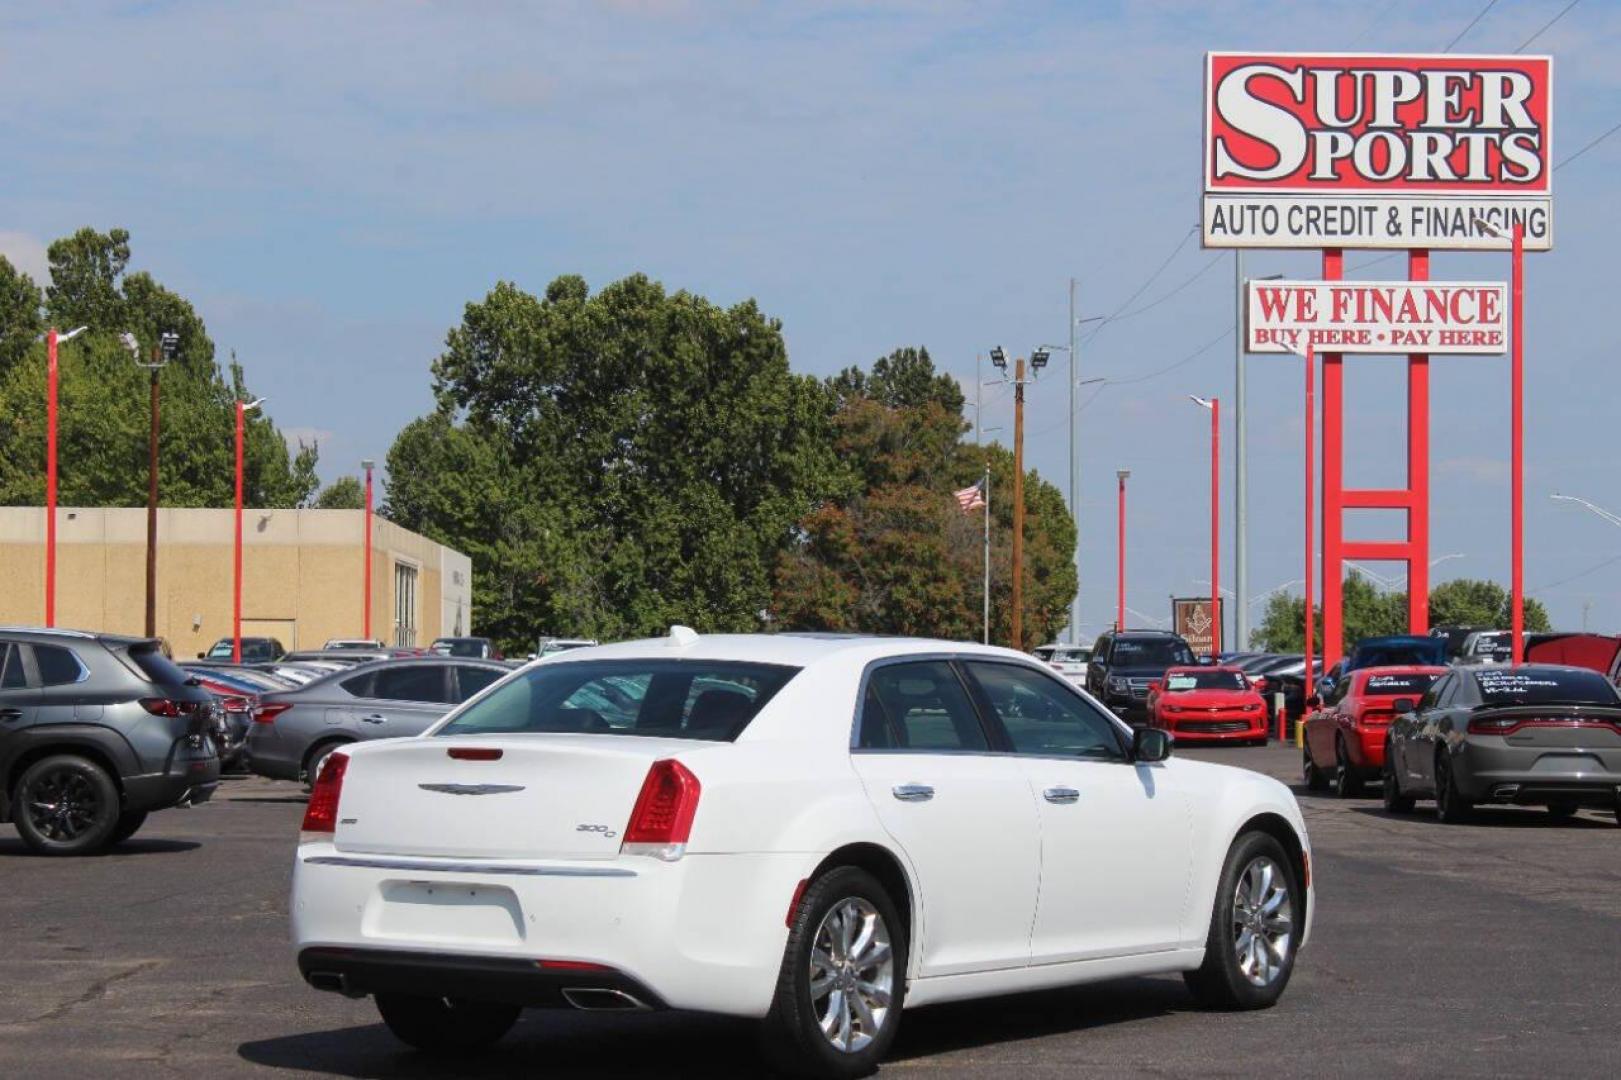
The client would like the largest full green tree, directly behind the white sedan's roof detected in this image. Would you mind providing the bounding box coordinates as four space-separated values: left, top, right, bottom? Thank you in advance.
387 276 838 647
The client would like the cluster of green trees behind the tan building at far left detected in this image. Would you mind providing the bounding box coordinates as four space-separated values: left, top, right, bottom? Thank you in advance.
0 229 318 508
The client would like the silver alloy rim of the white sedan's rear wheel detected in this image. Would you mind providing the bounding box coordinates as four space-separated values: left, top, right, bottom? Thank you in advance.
809 897 895 1054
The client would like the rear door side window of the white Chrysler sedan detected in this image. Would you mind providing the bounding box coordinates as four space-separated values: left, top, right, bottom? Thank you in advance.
858 660 990 752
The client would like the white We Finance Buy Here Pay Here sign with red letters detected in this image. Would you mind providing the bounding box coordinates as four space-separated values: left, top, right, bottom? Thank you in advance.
1245 281 1508 355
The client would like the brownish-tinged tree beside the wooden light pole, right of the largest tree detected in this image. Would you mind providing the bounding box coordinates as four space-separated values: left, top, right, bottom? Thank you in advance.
773 349 1075 647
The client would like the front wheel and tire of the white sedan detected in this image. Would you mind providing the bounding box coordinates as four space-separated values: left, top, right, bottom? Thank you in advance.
1182 832 1305 1010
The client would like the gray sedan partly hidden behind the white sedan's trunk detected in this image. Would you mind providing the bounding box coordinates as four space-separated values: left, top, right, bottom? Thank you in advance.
246 657 512 780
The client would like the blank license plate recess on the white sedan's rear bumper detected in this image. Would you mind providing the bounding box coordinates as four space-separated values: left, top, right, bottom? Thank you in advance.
361 881 524 945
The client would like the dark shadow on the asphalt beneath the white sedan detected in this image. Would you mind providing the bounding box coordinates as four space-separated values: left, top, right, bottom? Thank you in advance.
237 978 1193 1080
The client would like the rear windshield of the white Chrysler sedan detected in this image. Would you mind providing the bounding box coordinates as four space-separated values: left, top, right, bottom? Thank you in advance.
438 660 799 743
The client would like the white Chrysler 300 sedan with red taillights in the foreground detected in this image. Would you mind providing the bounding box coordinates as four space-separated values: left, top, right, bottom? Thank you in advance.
292 628 1313 1077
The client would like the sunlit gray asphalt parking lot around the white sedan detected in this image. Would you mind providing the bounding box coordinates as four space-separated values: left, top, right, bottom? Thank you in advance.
0 748 1621 1078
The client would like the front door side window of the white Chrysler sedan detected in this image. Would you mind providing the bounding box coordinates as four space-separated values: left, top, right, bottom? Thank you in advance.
963 660 1125 761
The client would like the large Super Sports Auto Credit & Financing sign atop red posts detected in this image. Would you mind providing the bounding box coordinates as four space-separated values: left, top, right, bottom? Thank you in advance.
1203 52 1553 248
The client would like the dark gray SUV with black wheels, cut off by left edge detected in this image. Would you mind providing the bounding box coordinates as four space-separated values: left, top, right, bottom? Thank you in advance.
0 628 219 855
